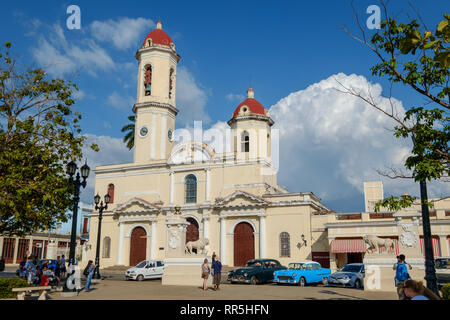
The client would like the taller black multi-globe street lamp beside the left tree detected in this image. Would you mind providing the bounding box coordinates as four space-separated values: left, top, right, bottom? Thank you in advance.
67 161 91 265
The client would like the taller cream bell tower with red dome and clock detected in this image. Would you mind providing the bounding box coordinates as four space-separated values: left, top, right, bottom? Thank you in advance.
133 21 180 163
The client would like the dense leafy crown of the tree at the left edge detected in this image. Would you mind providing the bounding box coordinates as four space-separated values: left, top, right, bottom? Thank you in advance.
0 42 98 235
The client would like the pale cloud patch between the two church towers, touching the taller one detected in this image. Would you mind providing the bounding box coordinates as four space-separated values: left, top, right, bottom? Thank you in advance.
176 66 211 125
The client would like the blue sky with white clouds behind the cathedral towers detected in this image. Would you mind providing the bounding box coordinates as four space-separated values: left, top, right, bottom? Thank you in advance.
0 0 449 211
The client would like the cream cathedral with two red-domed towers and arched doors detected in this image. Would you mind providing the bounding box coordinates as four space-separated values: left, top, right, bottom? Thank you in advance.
88 21 329 267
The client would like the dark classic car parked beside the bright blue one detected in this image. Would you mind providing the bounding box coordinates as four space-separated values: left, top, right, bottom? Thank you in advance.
228 259 287 284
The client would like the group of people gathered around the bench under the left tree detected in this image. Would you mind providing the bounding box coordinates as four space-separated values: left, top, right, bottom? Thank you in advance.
18 255 67 286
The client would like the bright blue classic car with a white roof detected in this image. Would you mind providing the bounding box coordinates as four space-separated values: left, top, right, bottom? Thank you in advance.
273 261 331 287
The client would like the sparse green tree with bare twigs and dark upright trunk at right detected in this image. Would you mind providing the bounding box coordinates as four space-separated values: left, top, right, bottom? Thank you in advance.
343 0 450 293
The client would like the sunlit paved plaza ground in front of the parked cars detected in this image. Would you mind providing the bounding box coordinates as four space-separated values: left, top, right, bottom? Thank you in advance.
50 279 397 300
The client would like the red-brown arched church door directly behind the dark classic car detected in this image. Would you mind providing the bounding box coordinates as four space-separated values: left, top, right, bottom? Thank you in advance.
234 222 255 266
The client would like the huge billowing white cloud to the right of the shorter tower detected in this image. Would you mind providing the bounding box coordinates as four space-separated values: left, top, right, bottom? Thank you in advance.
270 73 450 209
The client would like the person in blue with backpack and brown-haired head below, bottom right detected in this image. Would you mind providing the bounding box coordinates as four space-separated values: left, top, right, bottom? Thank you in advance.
393 254 440 300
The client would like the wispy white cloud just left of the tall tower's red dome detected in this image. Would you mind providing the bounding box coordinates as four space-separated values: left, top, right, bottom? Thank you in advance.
90 17 155 50
